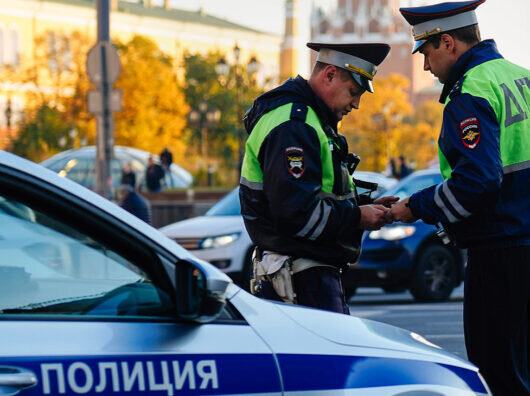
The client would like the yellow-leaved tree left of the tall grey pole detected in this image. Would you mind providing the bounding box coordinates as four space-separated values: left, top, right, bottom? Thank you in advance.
10 31 95 161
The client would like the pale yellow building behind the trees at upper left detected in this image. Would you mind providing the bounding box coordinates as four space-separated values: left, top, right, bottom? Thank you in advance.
0 0 282 148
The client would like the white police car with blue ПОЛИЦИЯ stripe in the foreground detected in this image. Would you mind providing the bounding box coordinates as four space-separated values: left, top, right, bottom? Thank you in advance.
0 152 490 396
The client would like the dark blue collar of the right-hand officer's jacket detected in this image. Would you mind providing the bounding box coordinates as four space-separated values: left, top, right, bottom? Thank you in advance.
440 40 502 104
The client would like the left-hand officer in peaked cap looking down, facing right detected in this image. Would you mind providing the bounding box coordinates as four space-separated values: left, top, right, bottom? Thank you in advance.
240 43 397 313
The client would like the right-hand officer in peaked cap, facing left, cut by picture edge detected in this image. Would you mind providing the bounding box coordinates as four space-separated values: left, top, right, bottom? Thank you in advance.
392 0 530 395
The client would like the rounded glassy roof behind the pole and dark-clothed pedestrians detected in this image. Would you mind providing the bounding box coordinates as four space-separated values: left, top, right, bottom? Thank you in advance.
40 146 193 190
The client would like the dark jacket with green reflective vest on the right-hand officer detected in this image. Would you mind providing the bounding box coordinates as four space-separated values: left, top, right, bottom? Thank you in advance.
409 40 530 251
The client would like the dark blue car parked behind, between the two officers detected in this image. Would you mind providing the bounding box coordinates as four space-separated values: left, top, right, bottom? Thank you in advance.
343 168 466 301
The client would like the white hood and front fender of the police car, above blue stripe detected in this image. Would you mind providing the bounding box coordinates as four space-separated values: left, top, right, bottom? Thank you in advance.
228 285 476 370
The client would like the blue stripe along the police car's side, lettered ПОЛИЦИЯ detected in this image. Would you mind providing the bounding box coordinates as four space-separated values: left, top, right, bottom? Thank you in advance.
0 353 487 395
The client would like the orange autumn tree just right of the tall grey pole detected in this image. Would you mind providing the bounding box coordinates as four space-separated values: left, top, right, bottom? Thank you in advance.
114 36 189 163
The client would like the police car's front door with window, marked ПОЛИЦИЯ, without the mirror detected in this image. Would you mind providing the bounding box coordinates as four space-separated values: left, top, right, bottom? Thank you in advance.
0 165 281 395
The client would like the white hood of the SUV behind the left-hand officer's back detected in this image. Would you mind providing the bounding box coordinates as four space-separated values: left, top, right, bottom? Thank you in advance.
160 216 245 238
